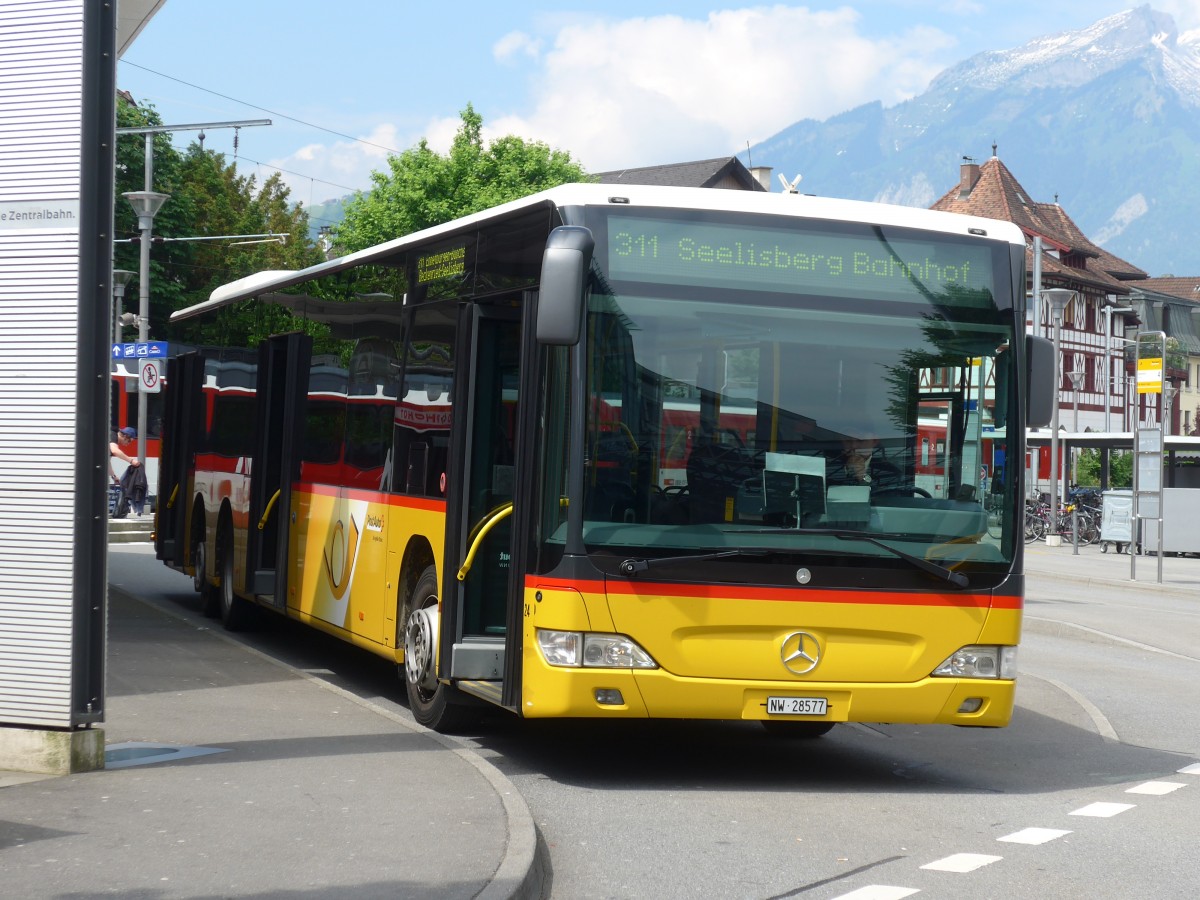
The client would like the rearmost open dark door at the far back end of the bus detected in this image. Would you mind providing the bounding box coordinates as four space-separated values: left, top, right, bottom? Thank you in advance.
155 353 204 569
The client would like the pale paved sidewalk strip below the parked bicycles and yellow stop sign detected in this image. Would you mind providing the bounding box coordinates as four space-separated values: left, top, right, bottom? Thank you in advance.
1025 541 1200 600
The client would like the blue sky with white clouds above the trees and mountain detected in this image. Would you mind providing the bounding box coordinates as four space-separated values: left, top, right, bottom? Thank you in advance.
118 0 1200 213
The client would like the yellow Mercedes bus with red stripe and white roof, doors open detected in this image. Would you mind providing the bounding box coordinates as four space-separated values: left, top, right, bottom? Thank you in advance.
156 185 1054 736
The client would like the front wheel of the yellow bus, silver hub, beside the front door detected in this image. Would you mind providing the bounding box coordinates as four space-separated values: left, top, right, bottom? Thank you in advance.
404 565 476 731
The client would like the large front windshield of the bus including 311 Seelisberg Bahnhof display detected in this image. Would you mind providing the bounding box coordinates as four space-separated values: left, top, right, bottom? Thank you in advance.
573 208 1022 577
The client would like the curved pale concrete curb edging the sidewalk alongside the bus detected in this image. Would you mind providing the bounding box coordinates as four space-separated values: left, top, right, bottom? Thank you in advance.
108 584 547 900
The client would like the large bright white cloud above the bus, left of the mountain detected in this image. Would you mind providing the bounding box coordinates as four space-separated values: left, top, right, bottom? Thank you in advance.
490 6 953 170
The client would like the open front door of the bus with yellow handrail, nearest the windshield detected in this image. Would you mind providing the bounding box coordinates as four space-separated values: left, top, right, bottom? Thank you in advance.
439 307 521 702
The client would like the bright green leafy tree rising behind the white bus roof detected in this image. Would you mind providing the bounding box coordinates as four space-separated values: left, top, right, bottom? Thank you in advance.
335 103 589 253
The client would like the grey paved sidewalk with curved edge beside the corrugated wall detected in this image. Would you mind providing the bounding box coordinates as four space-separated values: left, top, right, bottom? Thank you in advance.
0 588 542 900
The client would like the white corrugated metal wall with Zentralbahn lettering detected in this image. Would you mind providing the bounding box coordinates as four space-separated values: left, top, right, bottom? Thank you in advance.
0 0 84 727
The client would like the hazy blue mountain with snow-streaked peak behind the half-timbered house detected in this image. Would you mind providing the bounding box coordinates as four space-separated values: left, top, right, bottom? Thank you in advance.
752 6 1200 274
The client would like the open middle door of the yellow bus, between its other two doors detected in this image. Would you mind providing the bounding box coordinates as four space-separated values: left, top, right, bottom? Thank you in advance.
246 332 312 610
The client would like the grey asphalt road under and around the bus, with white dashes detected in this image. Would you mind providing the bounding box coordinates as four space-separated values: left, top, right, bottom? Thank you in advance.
110 548 1200 900
